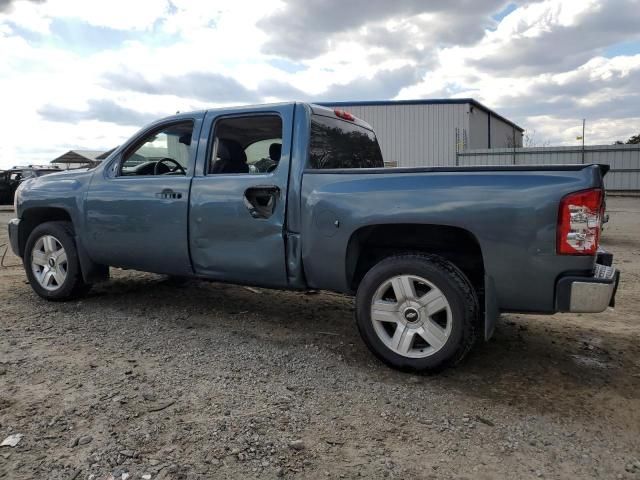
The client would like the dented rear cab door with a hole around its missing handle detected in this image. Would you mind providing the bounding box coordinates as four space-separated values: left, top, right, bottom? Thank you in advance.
189 105 293 287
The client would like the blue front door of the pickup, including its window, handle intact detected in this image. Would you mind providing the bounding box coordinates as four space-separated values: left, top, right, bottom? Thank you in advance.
86 119 200 275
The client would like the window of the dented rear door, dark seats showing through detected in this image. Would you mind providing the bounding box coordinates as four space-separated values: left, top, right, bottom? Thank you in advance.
207 115 282 175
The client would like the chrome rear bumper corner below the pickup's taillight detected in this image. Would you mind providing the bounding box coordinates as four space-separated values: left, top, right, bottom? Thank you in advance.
556 263 620 313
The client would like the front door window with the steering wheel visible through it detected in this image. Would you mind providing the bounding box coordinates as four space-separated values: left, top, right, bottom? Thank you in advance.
120 121 193 176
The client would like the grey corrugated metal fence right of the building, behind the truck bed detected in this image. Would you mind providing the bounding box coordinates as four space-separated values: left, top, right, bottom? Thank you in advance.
457 145 640 191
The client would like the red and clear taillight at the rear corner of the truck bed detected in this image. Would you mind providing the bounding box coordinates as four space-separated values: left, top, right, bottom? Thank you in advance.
557 188 603 255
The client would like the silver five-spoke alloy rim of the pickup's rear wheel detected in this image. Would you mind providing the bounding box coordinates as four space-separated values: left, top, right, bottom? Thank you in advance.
371 275 452 358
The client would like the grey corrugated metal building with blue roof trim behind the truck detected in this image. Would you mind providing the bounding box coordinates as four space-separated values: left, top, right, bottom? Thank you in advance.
322 98 524 167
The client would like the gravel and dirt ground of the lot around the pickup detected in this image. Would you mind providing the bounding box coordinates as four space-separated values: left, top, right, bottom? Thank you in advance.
0 198 640 480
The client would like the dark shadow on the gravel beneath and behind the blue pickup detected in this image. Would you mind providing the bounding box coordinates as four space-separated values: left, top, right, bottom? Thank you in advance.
86 274 640 417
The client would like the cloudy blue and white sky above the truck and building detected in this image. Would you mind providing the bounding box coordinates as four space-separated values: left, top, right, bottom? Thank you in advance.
0 0 640 167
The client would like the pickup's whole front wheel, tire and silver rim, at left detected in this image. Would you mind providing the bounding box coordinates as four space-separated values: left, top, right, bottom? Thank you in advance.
23 222 91 300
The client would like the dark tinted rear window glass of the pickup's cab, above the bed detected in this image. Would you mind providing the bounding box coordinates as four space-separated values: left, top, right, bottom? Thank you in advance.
309 115 384 169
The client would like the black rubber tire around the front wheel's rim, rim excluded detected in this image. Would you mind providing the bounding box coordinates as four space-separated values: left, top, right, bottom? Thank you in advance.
22 221 91 301
